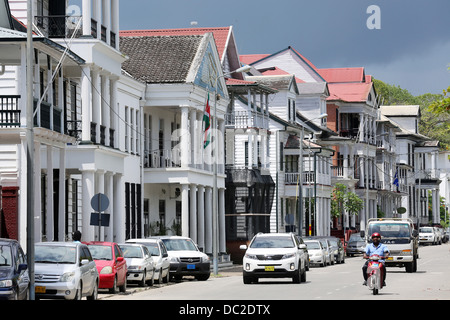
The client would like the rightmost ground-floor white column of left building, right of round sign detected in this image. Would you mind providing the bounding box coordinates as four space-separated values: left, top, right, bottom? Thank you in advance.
111 173 125 243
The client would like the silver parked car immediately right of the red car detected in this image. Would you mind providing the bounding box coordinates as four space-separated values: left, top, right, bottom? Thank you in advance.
119 243 155 287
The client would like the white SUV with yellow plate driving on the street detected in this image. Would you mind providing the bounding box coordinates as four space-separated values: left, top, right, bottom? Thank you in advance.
240 233 307 284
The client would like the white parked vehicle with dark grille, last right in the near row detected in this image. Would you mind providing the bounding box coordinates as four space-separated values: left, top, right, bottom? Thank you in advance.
152 236 211 281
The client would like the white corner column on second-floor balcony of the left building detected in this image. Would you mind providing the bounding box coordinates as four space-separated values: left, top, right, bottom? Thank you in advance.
81 66 92 142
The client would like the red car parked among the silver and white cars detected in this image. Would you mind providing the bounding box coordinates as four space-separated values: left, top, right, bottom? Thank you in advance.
84 241 128 293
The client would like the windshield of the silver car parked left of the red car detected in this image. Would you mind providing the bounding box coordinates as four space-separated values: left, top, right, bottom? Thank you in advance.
34 246 77 264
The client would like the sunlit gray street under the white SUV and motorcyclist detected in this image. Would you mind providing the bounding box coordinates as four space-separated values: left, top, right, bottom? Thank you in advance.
99 243 450 302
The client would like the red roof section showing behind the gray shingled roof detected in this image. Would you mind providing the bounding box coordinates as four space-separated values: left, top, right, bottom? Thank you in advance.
120 27 231 60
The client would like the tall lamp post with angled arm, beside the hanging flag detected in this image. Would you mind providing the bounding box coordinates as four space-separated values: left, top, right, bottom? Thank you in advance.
211 65 251 275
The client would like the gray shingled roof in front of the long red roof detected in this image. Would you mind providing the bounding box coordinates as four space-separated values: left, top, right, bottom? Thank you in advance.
120 36 203 83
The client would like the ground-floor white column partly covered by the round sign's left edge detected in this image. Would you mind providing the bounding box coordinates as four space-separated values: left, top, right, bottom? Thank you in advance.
81 169 95 241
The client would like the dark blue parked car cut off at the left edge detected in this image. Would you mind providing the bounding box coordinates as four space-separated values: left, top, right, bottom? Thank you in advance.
0 239 30 300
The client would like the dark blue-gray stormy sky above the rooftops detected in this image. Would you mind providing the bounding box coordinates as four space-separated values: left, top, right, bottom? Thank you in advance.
120 0 450 95
